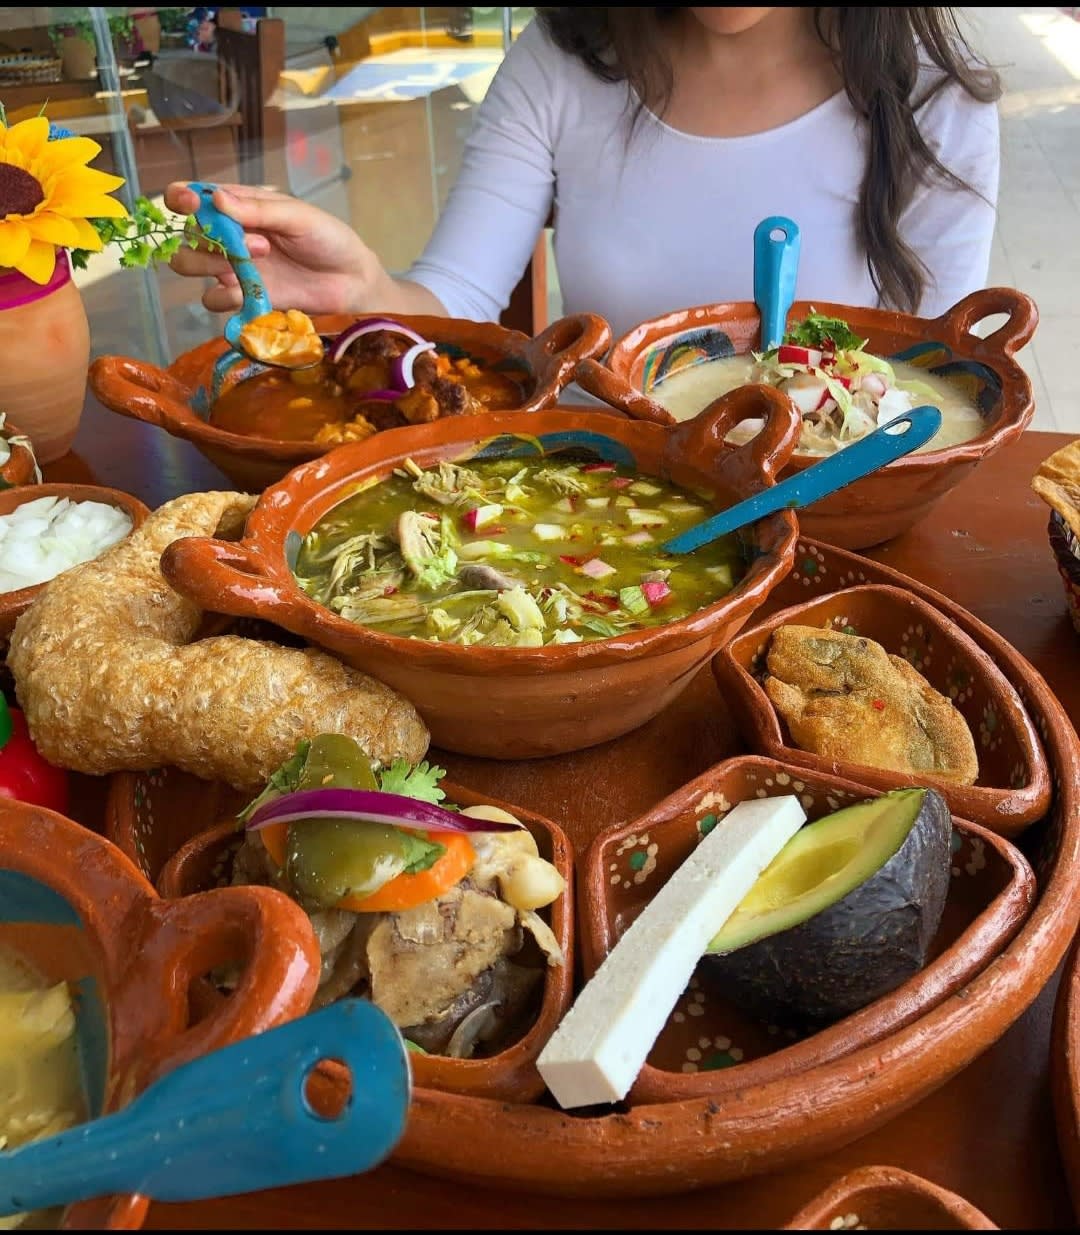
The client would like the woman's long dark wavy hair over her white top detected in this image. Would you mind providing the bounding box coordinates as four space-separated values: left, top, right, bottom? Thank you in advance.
536 5 1001 312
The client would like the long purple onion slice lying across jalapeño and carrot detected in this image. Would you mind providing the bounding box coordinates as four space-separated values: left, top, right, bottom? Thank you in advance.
247 788 524 832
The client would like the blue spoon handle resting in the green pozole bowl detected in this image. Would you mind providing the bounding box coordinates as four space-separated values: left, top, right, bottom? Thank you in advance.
660 405 942 553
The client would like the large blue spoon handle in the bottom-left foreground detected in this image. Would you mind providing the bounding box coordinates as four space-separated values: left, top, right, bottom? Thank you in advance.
0 999 411 1216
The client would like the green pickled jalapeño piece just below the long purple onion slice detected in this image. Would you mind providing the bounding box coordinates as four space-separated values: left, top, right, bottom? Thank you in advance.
285 818 409 909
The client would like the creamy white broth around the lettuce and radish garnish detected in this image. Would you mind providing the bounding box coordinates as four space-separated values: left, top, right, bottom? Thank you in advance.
649 354 986 454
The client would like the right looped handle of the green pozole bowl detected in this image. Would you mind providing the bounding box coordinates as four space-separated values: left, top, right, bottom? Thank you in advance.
665 383 802 498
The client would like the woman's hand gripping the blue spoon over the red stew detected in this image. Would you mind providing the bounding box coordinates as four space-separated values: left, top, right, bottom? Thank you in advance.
164 182 385 314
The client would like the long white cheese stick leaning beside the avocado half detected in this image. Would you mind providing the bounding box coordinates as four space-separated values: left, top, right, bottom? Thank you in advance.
536 795 806 1109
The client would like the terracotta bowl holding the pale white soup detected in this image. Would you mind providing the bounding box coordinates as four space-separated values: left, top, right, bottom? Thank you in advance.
577 288 1039 548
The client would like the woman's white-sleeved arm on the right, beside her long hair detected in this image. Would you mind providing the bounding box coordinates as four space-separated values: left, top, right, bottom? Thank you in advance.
900 84 1001 317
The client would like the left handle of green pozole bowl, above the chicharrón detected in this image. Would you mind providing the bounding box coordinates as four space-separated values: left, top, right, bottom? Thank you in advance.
161 536 304 635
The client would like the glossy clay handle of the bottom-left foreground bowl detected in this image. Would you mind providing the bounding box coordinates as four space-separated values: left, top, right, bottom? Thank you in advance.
114 885 321 1089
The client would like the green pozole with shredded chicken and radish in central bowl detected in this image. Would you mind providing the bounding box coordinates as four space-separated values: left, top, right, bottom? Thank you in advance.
294 458 744 647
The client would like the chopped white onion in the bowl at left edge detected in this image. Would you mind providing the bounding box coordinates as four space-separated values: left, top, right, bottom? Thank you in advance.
0 496 132 593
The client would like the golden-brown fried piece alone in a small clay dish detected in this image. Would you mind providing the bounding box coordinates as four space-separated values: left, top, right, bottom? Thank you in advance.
765 626 979 784
